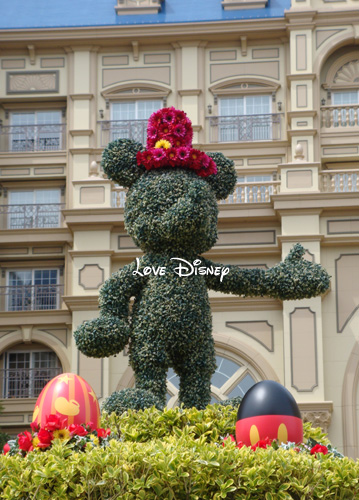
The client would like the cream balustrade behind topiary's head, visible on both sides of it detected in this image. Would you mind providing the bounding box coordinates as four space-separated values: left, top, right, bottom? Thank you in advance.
112 181 280 208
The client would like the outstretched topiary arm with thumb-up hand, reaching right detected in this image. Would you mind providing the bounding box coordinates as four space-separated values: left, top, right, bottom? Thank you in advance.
205 243 330 300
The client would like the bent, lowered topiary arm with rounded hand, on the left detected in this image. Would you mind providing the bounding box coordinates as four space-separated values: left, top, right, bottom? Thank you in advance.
74 262 145 358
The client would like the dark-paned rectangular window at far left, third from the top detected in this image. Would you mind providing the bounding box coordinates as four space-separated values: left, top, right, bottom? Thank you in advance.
6 269 60 311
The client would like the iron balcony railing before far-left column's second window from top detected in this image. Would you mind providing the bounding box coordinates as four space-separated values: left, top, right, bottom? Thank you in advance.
0 203 65 229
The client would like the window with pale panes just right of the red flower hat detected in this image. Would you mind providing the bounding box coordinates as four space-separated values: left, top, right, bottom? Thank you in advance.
218 95 273 142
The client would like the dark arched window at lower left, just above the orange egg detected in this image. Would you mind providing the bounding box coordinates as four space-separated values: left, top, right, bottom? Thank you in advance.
2 350 62 399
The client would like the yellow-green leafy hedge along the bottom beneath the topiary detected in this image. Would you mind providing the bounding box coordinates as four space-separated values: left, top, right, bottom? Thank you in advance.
0 405 359 500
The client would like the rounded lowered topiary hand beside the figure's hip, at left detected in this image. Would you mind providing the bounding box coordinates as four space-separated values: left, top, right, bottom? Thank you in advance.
74 314 130 358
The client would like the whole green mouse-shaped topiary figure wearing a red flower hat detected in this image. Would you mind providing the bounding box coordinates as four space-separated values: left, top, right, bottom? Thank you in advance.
74 108 329 408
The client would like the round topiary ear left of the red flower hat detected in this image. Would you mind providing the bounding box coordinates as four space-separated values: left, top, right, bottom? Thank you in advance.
101 139 145 187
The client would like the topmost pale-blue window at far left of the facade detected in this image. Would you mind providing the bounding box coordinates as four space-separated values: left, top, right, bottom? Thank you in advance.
10 111 64 151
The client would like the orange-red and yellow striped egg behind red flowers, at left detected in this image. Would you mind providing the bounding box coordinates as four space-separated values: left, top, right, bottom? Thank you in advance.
32 373 100 427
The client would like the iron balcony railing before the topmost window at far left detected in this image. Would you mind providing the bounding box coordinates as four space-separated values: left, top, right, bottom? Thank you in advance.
0 124 66 153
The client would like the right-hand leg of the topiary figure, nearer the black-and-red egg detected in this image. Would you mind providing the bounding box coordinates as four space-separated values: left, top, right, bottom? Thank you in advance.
174 337 216 409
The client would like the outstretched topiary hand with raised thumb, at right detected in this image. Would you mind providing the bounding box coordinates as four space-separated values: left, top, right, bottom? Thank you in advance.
265 243 330 300
